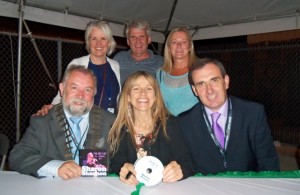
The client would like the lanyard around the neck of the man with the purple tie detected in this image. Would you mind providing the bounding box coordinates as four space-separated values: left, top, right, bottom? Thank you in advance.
202 98 232 168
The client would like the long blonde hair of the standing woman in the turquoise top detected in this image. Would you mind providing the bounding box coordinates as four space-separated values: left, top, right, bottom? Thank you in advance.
162 27 197 73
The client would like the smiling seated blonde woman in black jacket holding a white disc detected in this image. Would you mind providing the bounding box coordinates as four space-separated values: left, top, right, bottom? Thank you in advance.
108 71 194 185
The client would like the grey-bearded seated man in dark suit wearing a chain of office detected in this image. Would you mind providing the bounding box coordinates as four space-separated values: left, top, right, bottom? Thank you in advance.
9 65 115 179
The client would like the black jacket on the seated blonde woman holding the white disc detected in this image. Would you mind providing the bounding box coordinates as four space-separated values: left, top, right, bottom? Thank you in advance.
110 116 194 179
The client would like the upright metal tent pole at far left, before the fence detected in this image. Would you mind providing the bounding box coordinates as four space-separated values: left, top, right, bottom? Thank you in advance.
16 0 24 142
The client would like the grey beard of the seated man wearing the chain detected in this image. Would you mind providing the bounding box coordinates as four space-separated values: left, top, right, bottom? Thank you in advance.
62 96 93 117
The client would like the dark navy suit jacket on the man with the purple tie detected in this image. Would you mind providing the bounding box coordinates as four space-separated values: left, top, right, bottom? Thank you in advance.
178 97 279 174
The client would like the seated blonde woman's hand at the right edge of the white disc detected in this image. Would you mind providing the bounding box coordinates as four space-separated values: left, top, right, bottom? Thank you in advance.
163 161 183 183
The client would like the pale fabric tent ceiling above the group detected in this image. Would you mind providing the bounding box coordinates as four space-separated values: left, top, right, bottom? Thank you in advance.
0 0 300 42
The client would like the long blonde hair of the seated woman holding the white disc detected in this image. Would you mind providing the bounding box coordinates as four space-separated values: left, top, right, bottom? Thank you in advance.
108 71 169 156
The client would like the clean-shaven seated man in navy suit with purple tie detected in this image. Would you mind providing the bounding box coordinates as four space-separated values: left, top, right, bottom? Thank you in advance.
178 58 279 174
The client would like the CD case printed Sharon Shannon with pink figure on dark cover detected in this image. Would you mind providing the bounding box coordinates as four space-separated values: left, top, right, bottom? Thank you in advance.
79 149 109 177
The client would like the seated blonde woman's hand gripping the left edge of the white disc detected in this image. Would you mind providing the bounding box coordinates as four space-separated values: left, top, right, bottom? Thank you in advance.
119 163 139 185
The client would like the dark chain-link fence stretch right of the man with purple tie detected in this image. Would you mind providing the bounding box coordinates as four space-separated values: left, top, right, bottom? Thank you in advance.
196 40 300 144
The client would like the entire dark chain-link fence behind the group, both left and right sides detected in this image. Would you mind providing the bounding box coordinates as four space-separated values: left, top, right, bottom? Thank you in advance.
0 33 300 153
